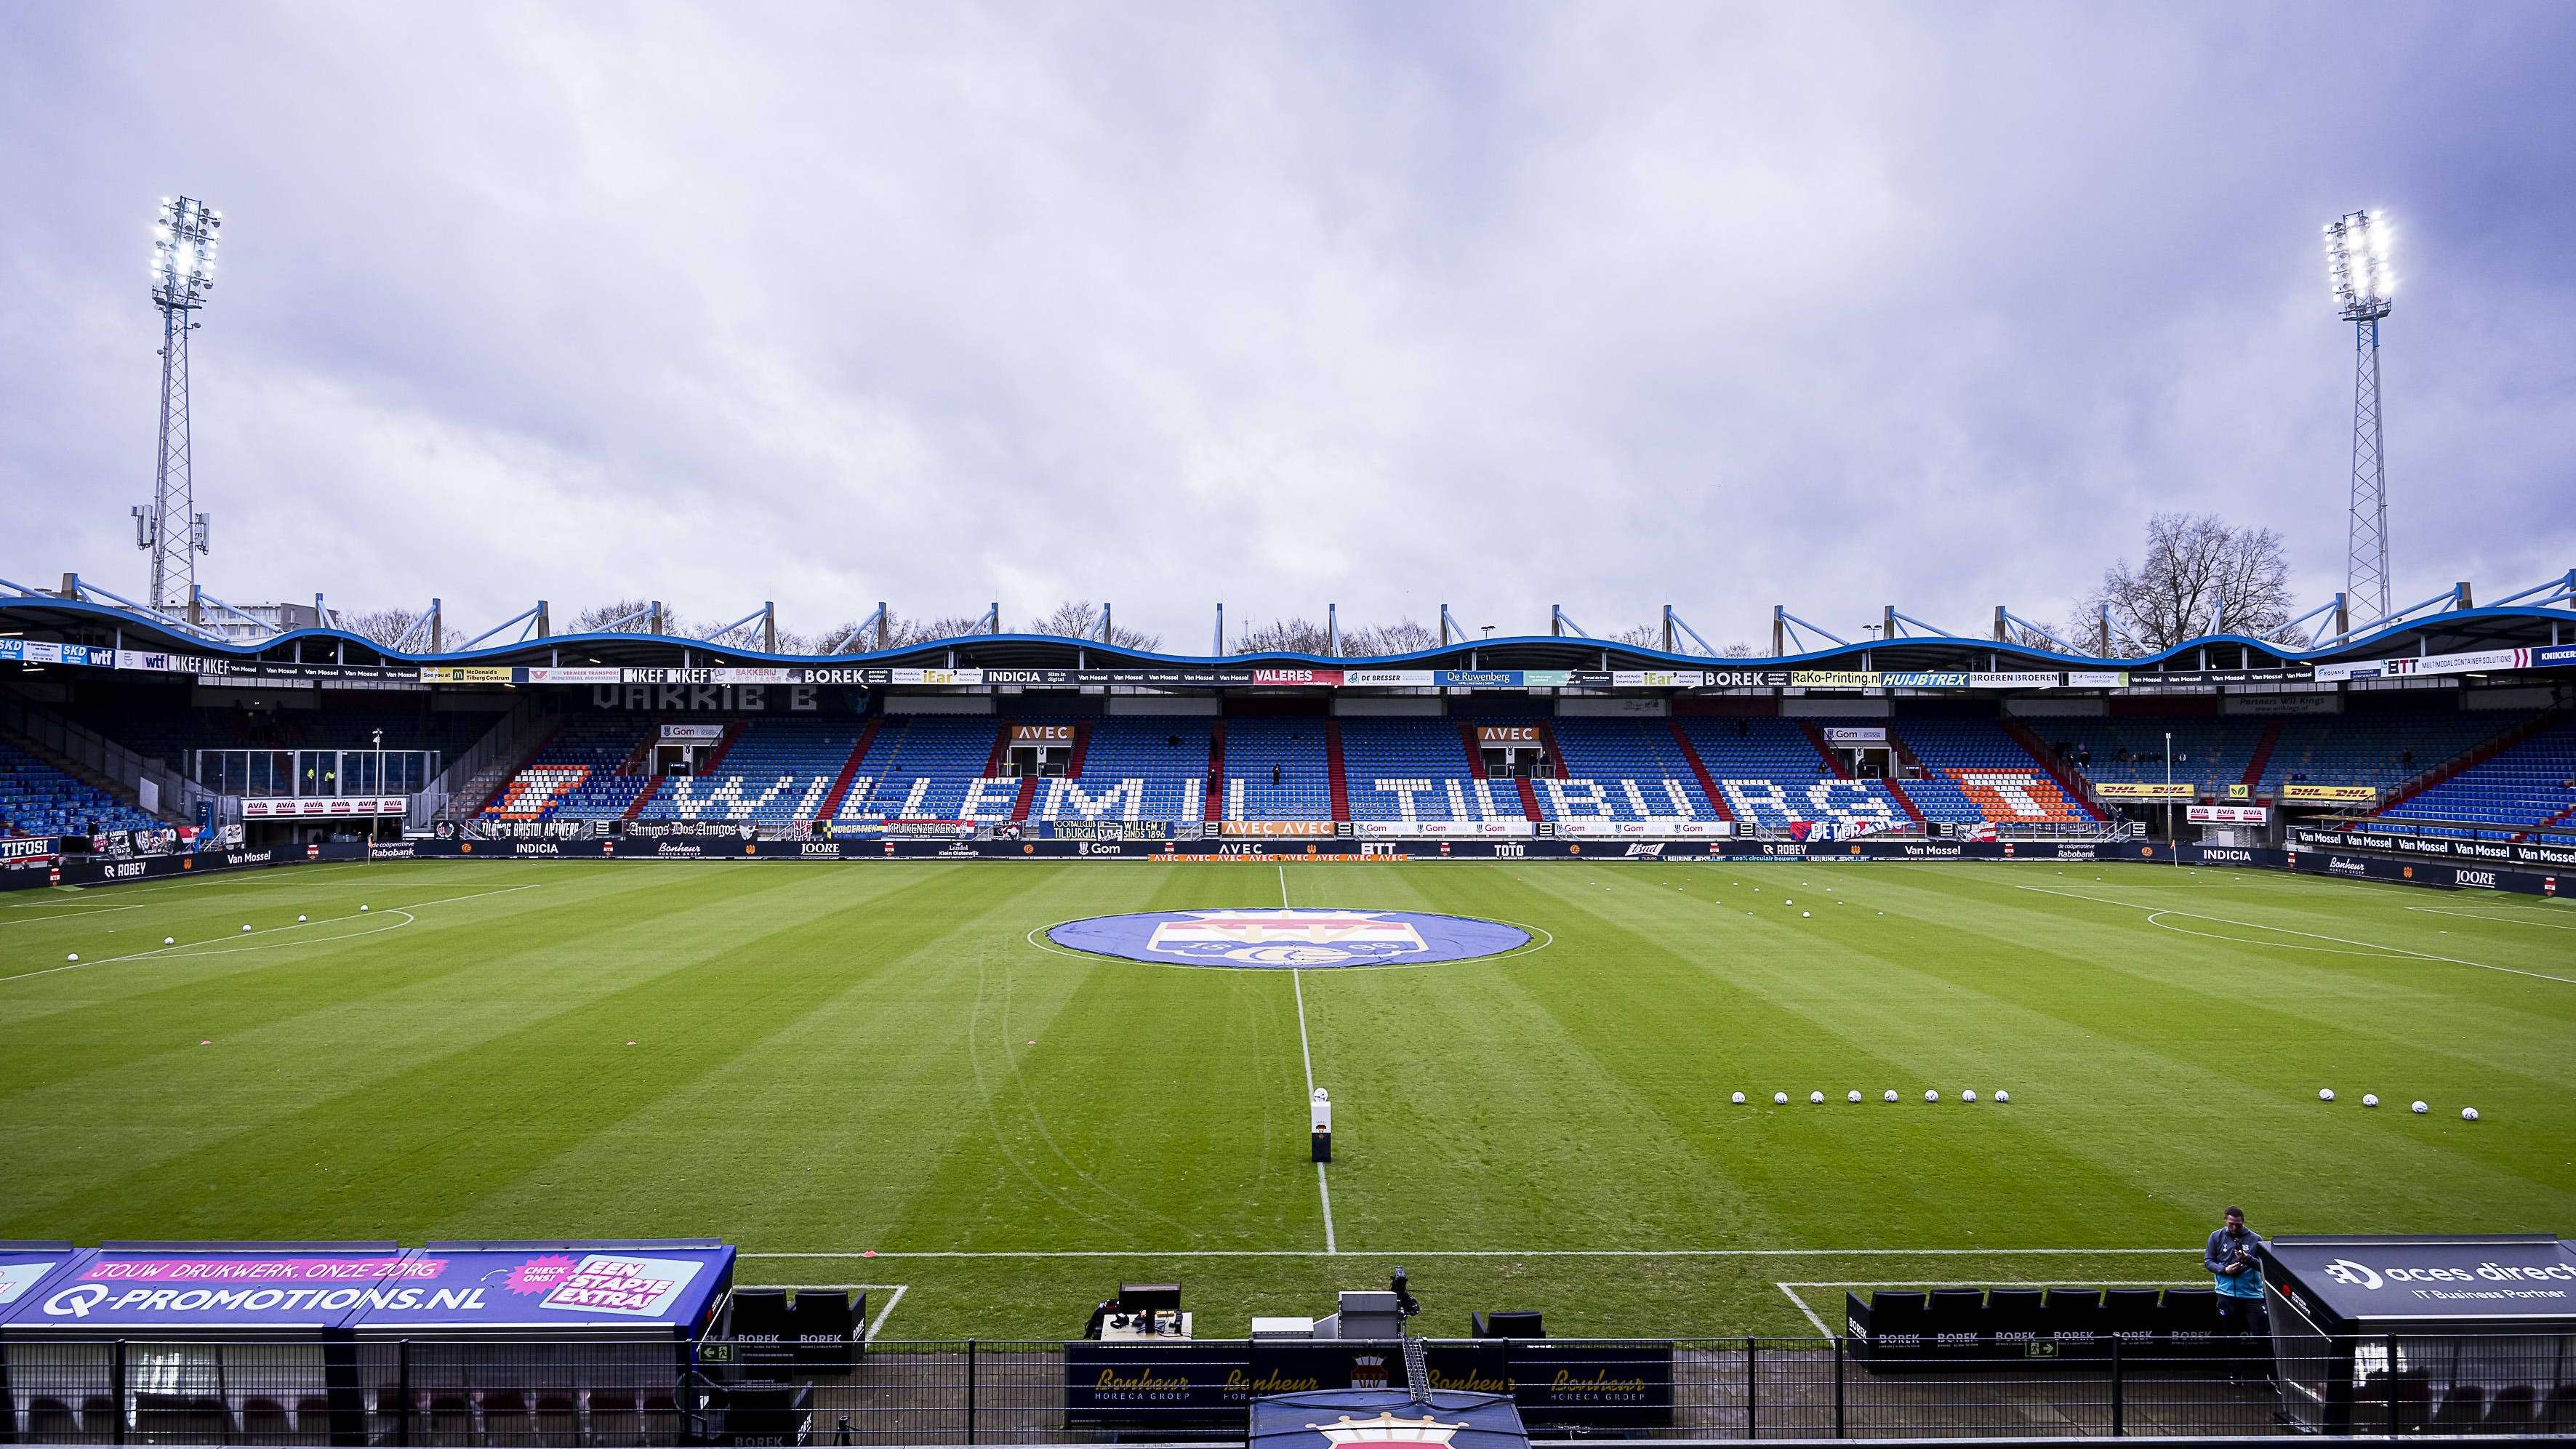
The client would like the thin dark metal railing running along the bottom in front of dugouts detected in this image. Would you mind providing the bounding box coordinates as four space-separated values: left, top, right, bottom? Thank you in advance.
0 1336 2576 1446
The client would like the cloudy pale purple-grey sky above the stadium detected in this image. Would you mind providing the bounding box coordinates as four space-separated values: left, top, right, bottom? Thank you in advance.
0 0 2576 651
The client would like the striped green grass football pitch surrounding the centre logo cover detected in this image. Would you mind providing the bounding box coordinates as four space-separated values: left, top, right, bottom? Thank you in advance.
0 862 2576 1338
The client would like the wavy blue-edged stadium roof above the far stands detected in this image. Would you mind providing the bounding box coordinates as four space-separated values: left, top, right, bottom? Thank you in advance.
0 571 2576 685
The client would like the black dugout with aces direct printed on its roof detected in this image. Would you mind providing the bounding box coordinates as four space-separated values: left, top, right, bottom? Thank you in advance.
2262 1235 2576 1434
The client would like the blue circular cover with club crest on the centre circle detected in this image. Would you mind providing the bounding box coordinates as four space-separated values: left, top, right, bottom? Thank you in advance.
1046 906 1530 968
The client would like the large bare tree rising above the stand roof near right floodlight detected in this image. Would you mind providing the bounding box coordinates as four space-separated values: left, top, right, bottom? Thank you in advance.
2082 512 2290 654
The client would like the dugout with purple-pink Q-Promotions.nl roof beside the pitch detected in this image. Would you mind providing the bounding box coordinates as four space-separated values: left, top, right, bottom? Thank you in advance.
0 1240 734 1444
